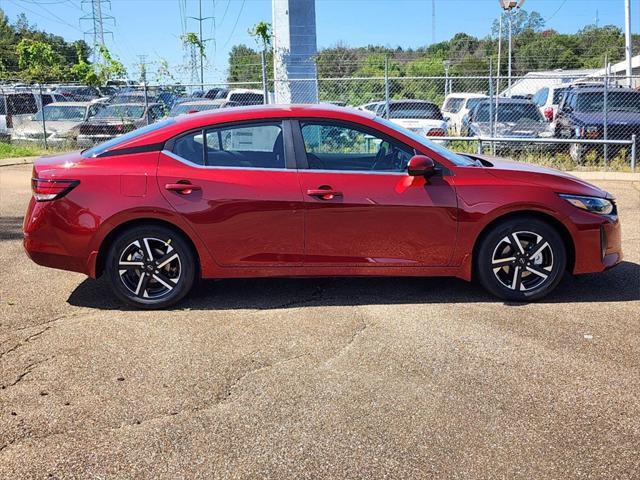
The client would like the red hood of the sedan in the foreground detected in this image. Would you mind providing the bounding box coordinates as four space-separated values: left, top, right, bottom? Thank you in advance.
468 154 611 198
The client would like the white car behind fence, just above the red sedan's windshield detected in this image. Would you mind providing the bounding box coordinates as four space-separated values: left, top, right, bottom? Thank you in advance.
376 100 447 141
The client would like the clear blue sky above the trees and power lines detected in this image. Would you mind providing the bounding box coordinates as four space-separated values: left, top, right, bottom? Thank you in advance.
0 0 640 81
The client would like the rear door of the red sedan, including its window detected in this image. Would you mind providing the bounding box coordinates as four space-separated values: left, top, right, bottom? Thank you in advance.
157 121 304 267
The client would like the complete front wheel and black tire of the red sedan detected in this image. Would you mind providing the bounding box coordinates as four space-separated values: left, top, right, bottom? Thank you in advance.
475 216 567 302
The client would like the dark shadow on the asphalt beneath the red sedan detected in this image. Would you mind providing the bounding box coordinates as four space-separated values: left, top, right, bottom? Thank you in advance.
68 262 640 310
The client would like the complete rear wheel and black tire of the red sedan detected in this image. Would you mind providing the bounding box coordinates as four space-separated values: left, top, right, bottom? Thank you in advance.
105 225 197 309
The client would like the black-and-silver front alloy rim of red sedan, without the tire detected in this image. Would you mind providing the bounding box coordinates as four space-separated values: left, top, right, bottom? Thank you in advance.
491 231 554 292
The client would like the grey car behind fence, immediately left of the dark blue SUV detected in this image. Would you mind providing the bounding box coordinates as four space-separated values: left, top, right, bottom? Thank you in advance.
462 98 552 151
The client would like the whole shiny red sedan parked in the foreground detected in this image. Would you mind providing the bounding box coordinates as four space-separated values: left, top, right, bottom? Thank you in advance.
24 105 621 308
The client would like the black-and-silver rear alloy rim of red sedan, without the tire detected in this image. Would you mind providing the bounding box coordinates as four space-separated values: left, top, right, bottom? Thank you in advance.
117 237 182 299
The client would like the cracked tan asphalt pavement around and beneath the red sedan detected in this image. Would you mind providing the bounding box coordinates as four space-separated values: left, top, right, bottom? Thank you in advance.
0 166 640 480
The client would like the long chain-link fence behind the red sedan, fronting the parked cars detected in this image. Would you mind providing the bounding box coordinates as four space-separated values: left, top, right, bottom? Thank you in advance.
0 72 640 169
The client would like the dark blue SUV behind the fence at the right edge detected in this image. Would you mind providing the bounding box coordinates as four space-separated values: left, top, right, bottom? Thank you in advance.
555 86 640 163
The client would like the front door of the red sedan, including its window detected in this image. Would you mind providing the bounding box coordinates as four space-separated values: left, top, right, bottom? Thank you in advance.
292 120 457 266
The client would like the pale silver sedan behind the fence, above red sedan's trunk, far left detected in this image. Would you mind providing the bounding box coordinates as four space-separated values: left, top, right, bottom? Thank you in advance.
11 102 104 144
